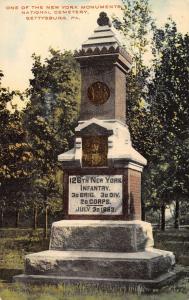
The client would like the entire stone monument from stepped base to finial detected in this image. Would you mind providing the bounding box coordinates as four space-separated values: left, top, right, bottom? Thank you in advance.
15 12 175 287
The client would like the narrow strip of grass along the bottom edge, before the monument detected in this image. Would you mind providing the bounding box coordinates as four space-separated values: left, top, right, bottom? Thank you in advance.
0 279 189 300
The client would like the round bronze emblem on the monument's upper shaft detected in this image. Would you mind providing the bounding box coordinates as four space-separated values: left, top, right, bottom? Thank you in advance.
88 81 110 105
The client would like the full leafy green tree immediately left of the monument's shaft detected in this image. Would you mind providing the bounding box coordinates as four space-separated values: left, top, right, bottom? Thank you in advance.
25 49 80 227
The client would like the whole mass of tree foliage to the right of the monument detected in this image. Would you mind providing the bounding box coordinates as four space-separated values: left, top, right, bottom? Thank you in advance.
114 0 189 225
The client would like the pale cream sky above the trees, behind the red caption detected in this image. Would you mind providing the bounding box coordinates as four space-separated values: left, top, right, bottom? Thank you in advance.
0 0 189 91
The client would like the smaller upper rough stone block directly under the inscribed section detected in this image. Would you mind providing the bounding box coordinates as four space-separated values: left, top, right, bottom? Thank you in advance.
49 220 154 252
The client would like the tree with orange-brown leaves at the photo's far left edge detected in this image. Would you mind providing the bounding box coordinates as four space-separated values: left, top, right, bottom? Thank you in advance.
0 72 32 226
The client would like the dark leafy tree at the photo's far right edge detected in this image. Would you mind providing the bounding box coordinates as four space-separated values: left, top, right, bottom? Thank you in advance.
149 19 189 227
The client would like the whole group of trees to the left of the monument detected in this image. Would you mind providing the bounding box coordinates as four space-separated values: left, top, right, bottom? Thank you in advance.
0 49 80 230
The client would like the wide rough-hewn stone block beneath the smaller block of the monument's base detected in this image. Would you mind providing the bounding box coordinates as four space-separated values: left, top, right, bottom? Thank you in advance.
25 249 173 279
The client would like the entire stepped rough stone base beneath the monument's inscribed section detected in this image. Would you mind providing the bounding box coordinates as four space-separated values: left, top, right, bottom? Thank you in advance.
14 220 175 287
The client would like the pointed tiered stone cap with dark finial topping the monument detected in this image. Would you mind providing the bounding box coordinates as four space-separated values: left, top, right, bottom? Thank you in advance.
75 12 132 65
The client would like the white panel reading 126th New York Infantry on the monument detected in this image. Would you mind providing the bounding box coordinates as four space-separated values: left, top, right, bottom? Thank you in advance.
68 175 123 215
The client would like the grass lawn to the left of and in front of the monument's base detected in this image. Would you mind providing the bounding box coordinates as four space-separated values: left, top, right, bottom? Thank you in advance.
0 229 189 300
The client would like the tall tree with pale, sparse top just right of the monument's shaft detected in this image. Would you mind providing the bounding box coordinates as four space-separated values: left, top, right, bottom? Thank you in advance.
114 0 158 159
